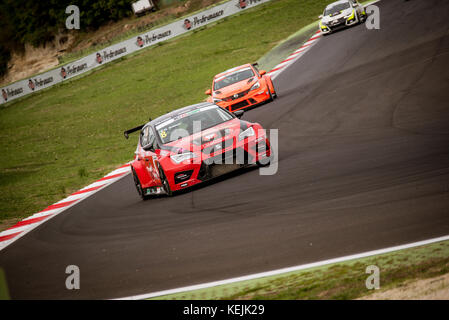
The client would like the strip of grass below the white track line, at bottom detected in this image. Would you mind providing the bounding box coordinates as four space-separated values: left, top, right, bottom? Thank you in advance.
150 241 449 300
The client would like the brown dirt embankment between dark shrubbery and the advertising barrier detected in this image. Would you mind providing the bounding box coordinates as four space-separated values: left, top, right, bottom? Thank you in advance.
0 0 222 86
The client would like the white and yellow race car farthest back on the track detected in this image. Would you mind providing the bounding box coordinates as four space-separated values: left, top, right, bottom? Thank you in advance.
319 0 366 34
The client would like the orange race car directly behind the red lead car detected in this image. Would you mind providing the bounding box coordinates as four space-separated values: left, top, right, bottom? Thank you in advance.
205 63 277 112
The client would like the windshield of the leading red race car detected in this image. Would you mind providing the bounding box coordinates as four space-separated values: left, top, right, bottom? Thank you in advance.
156 105 233 144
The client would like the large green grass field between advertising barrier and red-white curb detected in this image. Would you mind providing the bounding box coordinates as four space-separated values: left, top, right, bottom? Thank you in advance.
0 0 327 228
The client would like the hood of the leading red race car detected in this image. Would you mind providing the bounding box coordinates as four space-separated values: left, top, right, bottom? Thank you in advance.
161 119 249 154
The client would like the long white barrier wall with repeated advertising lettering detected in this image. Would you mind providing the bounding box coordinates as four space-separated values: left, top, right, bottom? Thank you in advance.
0 0 270 104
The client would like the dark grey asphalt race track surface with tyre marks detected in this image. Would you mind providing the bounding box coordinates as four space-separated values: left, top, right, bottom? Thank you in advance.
0 0 449 299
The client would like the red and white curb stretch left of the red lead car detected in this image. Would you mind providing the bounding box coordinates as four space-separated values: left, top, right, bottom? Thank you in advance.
0 163 131 250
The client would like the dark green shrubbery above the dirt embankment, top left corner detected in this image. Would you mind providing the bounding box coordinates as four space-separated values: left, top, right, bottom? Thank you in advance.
0 0 136 76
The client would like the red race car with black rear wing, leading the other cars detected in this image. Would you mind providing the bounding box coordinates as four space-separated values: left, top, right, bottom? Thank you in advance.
124 102 271 199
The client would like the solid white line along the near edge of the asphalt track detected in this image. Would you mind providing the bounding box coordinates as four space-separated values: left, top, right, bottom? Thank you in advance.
116 235 449 300
